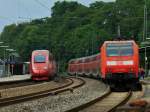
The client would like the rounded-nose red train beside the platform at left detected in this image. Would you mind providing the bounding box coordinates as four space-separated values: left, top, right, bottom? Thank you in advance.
30 50 56 80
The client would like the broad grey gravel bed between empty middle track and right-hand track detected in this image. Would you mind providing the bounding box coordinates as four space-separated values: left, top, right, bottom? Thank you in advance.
0 79 107 112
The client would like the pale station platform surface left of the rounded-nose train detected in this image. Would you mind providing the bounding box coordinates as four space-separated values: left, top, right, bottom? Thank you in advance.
0 74 31 83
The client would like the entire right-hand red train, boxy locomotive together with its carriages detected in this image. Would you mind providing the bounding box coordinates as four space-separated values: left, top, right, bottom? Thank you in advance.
68 40 139 87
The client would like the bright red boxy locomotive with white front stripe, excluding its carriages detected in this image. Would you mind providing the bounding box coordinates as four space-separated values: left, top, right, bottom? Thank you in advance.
101 41 139 86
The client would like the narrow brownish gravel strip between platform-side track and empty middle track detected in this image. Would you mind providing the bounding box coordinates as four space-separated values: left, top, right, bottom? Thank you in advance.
0 80 70 98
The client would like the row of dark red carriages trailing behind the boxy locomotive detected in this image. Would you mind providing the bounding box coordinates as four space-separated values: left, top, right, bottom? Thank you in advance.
68 54 100 77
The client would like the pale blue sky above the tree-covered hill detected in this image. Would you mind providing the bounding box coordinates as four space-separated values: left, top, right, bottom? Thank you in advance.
0 0 115 32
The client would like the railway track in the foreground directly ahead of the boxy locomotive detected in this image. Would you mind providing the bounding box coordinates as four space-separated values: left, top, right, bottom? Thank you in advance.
66 91 132 112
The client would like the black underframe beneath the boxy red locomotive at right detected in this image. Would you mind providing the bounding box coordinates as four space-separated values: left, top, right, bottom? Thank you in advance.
102 73 142 90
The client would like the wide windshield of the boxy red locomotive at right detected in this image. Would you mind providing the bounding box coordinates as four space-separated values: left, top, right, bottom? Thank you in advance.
106 43 133 56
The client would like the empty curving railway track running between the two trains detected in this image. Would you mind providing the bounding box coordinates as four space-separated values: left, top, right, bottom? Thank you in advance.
0 77 85 107
